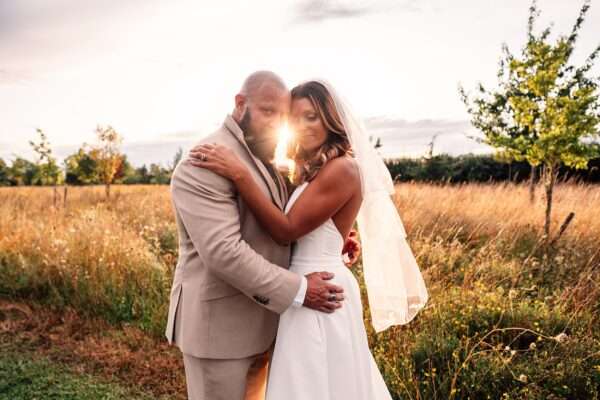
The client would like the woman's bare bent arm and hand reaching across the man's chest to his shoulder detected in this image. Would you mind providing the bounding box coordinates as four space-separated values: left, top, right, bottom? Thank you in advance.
190 145 360 244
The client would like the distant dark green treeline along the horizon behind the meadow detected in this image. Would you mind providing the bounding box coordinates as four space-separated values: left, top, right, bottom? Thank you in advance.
0 152 600 186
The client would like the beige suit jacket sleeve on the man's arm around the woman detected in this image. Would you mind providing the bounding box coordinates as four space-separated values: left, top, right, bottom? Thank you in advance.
171 161 302 314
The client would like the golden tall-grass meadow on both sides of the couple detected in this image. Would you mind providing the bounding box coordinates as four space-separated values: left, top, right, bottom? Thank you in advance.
0 183 600 399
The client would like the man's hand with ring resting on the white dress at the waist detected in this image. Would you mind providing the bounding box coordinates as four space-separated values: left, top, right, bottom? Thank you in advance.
304 272 344 313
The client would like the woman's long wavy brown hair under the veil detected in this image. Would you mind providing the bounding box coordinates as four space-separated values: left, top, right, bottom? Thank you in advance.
287 81 354 185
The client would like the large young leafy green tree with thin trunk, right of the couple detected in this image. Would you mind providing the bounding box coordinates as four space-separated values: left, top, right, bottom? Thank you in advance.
460 0 600 239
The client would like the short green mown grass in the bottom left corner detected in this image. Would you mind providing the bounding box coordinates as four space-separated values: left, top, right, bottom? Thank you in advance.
0 351 152 400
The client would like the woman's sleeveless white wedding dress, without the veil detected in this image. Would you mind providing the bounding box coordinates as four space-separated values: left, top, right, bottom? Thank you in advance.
266 183 392 400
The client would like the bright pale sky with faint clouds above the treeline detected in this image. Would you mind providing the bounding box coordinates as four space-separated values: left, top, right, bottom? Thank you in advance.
0 0 600 166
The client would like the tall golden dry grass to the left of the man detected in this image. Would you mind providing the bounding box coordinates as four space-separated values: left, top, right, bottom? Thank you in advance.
0 186 177 334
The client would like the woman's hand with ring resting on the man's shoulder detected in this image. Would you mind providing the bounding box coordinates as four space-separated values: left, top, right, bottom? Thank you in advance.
189 143 248 182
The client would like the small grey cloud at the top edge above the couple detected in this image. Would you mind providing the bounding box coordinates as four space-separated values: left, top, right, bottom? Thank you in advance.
294 0 420 23
